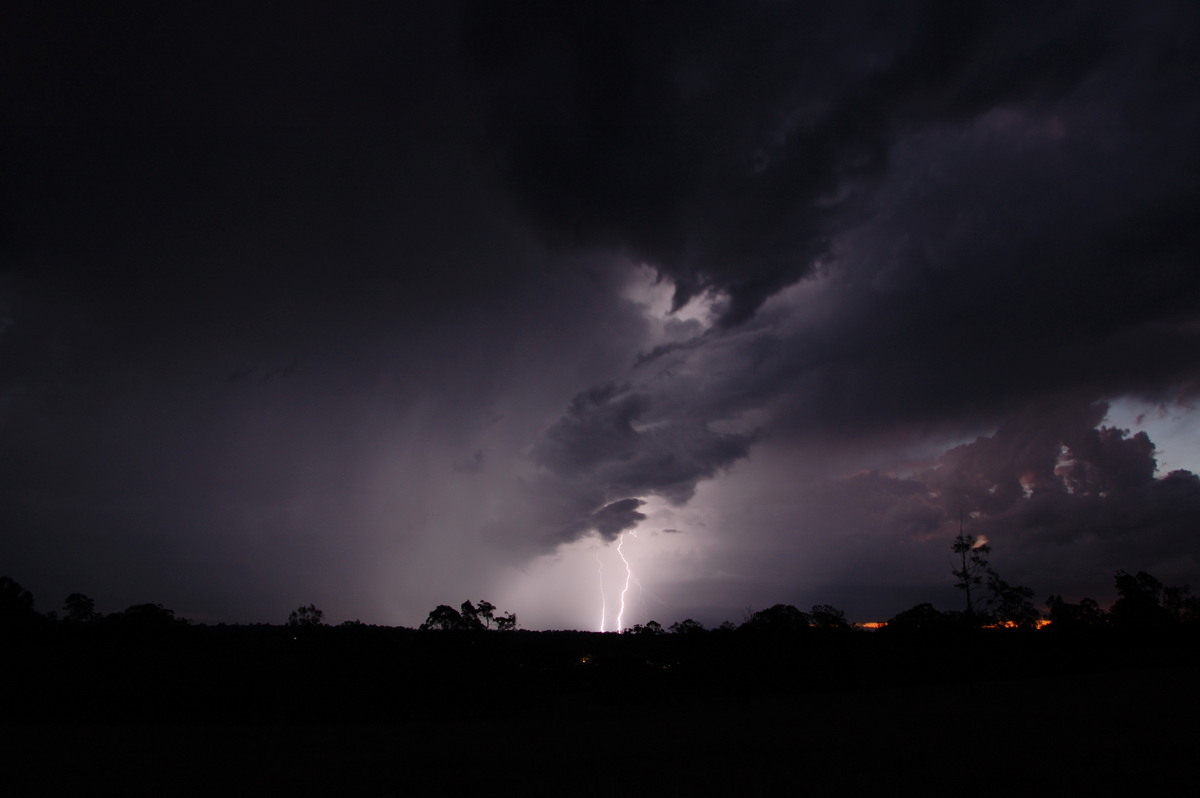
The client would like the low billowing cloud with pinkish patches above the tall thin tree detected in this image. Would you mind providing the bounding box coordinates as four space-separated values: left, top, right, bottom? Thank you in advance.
833 402 1200 592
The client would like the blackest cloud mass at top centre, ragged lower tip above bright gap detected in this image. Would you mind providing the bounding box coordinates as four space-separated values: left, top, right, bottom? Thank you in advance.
466 2 1121 324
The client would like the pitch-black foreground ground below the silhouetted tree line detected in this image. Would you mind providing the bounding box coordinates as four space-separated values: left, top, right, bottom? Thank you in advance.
0 630 1200 796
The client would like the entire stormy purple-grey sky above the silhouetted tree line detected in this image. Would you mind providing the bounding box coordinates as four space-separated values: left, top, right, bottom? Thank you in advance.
0 0 1200 629
